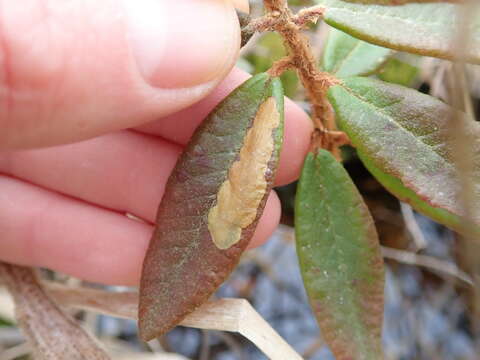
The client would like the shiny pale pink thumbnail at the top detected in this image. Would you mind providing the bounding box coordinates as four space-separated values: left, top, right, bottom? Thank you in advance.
124 0 240 88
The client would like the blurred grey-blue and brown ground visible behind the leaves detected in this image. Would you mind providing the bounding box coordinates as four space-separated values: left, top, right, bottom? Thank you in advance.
0 0 480 360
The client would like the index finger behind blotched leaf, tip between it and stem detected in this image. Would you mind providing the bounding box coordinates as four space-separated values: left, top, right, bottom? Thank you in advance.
137 68 313 185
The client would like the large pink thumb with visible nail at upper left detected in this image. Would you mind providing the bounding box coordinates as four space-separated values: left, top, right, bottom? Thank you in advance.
0 0 240 149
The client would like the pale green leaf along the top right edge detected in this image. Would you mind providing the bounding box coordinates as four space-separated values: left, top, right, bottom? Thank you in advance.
316 0 480 63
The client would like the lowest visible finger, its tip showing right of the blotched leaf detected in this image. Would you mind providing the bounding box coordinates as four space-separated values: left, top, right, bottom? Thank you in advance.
0 176 280 285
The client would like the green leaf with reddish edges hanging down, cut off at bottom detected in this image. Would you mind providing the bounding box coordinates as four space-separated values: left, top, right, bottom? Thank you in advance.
295 150 384 360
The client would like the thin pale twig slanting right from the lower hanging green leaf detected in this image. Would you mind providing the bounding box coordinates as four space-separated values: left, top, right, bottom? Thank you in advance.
382 246 473 286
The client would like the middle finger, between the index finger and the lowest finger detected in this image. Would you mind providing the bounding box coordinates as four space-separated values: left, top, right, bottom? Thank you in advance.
0 126 302 223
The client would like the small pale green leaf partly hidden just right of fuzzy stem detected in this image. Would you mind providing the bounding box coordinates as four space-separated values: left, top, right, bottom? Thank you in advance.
322 29 393 77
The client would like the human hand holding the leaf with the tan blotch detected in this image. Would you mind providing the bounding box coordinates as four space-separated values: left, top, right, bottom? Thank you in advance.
0 0 311 285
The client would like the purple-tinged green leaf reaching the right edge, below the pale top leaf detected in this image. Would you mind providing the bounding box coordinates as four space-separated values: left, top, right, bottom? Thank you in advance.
329 78 480 234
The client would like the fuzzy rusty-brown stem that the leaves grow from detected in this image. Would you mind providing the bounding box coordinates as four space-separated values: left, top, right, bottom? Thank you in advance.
264 0 339 158
